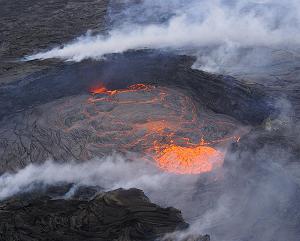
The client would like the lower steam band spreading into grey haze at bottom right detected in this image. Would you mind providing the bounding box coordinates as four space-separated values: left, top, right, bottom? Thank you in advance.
0 132 300 241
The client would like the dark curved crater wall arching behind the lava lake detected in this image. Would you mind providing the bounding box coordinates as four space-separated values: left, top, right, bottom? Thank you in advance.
0 51 274 125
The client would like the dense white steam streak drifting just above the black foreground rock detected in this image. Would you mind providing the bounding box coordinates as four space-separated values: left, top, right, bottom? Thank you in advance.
0 155 161 199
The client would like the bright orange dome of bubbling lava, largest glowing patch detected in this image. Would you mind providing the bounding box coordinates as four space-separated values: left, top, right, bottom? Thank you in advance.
156 145 224 174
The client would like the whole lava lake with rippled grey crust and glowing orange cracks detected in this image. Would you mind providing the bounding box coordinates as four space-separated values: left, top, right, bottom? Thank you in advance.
0 84 241 174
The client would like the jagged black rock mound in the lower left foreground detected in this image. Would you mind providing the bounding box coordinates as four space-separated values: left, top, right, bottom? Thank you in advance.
0 189 209 241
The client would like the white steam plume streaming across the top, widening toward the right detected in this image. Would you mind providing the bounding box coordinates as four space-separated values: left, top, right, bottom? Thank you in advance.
27 0 300 70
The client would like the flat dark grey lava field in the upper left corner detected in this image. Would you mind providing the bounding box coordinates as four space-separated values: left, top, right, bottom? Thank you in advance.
0 0 108 84
